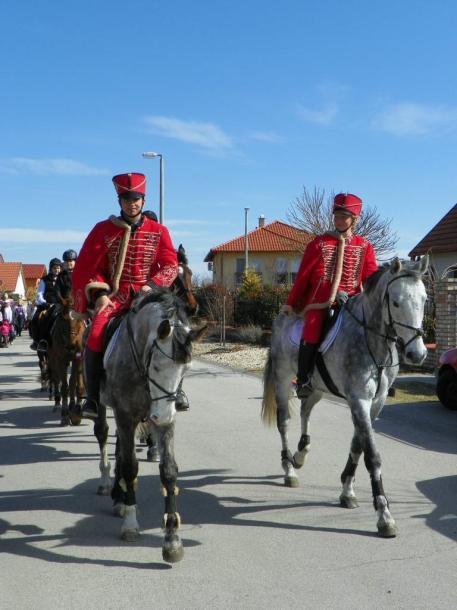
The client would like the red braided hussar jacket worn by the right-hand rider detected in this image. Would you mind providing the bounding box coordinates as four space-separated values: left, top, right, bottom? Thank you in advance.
287 233 378 311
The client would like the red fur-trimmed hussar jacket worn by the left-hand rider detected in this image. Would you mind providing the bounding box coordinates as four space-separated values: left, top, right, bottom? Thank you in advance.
72 216 178 313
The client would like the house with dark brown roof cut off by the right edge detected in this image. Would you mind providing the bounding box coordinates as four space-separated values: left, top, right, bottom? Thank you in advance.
408 204 457 277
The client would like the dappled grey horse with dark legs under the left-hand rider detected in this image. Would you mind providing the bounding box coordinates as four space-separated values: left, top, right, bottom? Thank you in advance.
94 289 204 563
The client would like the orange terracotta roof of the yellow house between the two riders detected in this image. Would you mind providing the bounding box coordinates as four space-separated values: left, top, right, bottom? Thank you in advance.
205 220 312 262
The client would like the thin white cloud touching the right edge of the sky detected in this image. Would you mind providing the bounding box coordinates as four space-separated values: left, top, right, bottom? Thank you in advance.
373 102 457 136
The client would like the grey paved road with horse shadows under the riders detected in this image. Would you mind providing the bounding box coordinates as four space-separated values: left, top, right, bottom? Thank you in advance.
0 337 457 610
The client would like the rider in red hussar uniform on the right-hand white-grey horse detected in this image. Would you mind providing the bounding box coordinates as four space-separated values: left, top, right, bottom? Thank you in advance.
282 193 378 398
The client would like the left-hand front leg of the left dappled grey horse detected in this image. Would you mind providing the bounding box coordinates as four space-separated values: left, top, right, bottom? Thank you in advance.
117 422 140 542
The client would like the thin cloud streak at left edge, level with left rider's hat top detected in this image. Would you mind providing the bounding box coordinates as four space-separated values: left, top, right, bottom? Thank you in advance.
0 157 109 176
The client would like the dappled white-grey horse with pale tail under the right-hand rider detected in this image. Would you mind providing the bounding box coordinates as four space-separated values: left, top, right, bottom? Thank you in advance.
262 257 428 537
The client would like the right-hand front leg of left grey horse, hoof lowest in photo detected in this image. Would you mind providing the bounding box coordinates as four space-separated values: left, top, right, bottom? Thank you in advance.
157 424 184 563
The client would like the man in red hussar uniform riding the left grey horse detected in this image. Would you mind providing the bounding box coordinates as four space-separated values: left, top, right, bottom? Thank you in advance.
72 173 178 419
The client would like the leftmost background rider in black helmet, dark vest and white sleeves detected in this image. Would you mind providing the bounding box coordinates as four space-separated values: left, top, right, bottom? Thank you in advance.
29 258 62 351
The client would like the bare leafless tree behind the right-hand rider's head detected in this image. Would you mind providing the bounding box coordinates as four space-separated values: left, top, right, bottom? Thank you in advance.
287 186 398 258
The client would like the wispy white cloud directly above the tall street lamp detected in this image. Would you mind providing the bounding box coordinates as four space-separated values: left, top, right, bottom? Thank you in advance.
145 116 233 152
